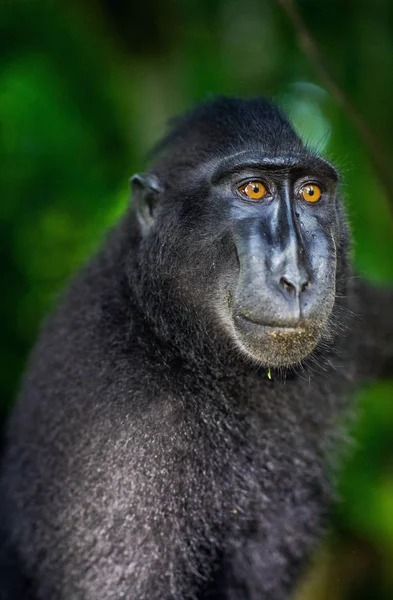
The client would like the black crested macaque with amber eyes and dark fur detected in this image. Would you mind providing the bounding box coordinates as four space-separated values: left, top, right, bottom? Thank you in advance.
0 98 393 600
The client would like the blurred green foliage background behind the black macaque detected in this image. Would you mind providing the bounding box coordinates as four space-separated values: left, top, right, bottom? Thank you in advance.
0 0 393 600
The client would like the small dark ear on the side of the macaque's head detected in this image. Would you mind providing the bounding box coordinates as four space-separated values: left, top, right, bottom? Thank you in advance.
130 173 163 235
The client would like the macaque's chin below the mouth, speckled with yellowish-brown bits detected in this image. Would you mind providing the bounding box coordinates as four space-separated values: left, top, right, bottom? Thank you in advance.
232 316 321 367
